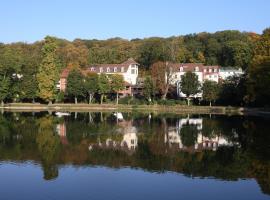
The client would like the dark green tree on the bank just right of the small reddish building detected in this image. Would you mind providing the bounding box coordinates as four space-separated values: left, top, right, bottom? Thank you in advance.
67 69 84 104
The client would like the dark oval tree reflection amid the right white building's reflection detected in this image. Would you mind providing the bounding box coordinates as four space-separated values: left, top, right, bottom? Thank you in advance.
180 124 198 147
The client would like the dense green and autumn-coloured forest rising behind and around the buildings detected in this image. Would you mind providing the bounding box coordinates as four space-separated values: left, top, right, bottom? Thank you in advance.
0 29 270 106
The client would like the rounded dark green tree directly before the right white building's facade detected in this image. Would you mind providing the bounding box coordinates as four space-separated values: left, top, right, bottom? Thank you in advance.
180 72 200 105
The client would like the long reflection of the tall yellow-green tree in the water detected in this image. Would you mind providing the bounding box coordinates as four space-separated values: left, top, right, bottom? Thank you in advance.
36 117 60 180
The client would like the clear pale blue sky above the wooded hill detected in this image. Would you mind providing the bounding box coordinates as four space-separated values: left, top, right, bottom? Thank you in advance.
0 0 270 43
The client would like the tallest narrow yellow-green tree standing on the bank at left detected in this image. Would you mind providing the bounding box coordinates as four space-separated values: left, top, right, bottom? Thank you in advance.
37 36 59 104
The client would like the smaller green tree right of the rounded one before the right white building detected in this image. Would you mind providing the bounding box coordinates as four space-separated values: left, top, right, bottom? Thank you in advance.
202 80 220 106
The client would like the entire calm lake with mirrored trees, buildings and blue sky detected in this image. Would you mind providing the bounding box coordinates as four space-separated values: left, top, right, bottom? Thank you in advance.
0 113 270 200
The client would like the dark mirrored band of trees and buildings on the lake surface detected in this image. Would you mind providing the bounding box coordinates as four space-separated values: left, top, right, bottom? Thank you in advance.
0 113 270 194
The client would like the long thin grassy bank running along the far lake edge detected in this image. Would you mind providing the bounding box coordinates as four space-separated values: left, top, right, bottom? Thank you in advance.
2 103 243 114
